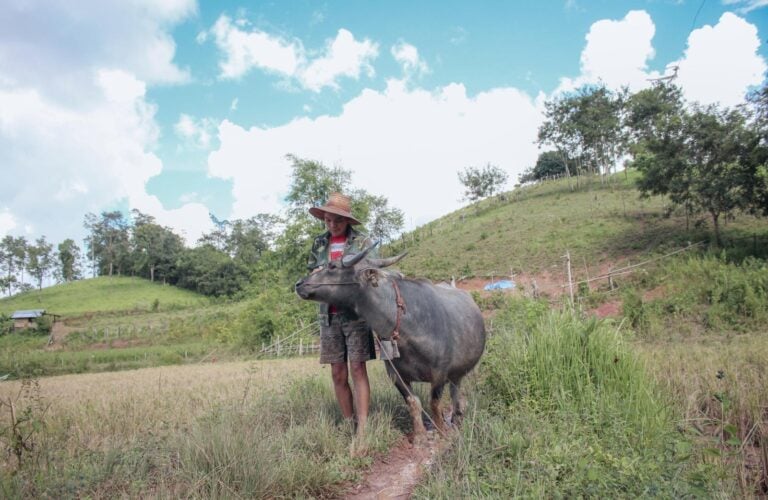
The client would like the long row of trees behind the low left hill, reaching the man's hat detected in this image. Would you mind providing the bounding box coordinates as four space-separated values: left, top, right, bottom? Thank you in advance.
0 155 403 297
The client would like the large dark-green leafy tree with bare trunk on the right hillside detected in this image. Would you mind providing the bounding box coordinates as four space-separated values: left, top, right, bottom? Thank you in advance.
628 85 755 244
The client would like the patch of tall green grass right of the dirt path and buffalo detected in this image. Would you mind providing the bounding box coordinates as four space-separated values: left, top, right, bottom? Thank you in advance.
416 298 714 498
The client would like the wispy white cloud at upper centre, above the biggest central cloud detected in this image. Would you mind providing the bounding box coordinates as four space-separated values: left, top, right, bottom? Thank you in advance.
211 15 378 92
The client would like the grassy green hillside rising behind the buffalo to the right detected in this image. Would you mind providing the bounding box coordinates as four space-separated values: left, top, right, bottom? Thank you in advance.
389 171 768 280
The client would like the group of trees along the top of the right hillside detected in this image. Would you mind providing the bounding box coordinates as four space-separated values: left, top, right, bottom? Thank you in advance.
519 81 768 243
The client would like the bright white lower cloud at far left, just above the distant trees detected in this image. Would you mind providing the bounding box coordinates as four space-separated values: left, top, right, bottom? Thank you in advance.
0 70 216 248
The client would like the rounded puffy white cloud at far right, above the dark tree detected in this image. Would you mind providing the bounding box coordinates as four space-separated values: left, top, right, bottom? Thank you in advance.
674 12 768 106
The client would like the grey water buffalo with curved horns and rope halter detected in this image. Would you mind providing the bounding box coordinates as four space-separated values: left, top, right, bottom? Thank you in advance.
296 248 485 437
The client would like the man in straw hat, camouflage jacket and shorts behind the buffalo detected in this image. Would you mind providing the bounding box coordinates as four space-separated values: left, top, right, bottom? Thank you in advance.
307 193 376 435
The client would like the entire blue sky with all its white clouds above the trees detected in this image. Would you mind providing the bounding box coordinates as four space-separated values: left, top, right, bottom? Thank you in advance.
0 0 768 248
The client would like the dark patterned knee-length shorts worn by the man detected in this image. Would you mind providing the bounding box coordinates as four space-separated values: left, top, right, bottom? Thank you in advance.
320 314 376 364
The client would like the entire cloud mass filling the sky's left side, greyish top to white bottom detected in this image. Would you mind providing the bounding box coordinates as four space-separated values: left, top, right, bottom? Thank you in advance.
0 0 216 246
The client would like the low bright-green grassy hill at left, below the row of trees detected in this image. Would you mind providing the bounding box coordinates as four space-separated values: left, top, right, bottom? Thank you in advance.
0 276 209 316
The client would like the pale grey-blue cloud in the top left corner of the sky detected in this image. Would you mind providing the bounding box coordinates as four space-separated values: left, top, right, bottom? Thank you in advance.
0 0 196 105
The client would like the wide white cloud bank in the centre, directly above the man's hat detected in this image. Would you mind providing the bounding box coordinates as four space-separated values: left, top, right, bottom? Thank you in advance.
208 80 541 229
